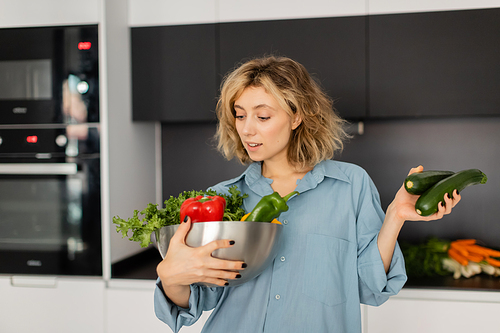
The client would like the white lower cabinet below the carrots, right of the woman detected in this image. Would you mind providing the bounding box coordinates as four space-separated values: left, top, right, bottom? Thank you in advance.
363 289 500 333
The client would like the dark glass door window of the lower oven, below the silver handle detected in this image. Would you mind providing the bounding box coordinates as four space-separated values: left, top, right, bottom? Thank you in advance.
0 176 84 250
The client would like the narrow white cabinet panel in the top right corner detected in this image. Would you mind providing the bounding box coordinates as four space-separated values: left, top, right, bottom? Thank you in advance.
367 0 500 15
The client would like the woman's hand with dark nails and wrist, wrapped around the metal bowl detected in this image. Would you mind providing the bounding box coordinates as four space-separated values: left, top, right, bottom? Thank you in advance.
156 218 246 307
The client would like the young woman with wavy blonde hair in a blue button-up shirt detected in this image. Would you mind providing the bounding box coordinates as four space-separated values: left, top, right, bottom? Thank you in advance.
155 57 460 333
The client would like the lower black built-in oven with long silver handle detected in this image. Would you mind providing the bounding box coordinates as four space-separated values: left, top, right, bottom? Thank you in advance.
0 124 102 276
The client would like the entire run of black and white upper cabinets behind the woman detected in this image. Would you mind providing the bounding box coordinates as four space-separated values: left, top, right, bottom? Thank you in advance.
129 0 500 122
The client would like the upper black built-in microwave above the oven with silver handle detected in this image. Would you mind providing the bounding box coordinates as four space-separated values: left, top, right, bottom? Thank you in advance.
0 25 99 125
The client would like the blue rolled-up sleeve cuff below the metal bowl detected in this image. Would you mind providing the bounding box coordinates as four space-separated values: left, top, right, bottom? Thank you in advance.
154 279 223 333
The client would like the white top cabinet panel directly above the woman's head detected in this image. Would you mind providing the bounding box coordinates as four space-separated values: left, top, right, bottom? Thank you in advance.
218 0 366 22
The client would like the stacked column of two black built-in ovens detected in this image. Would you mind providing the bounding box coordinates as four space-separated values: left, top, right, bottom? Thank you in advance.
0 25 103 276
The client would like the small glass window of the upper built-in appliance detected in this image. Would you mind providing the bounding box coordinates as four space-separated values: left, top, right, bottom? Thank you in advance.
0 59 52 100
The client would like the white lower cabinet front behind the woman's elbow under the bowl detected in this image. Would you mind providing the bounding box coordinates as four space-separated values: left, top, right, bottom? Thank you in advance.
106 279 210 333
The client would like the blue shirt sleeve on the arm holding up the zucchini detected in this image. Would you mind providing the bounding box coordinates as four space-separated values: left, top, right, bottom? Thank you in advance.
357 175 407 306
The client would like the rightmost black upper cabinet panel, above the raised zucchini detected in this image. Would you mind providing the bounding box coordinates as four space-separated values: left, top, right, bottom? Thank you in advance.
368 9 500 118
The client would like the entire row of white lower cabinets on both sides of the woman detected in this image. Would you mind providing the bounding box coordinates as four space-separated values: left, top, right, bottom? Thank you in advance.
0 276 500 333
